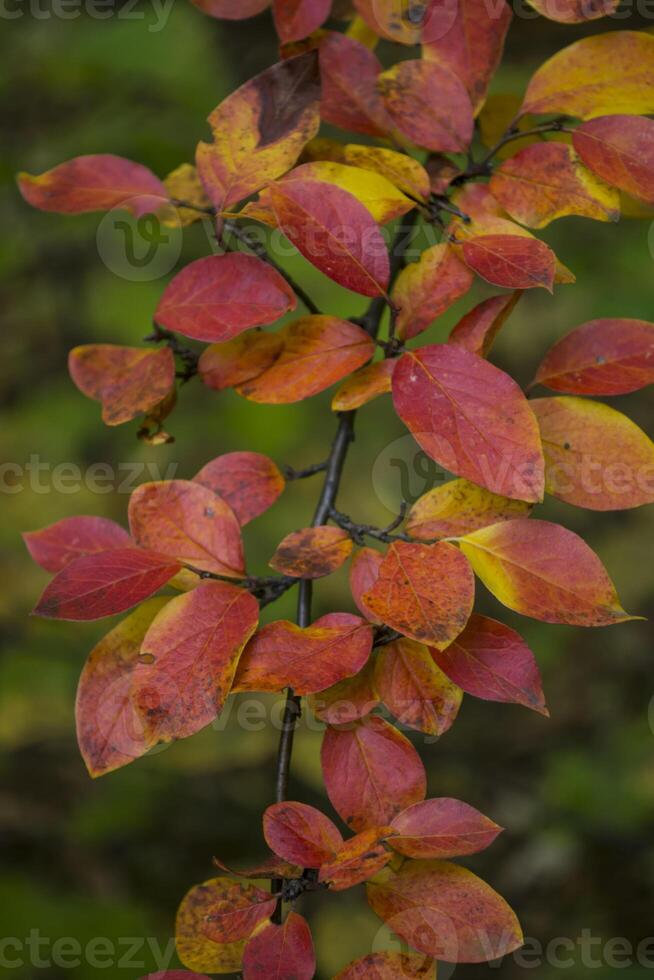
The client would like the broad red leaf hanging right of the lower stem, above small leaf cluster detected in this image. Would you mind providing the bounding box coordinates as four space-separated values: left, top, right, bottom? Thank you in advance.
321 715 427 831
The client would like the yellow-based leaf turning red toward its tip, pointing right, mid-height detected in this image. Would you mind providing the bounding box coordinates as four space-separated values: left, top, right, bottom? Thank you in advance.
459 519 632 626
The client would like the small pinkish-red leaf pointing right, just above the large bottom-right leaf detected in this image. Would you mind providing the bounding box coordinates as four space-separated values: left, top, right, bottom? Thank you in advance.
389 797 502 858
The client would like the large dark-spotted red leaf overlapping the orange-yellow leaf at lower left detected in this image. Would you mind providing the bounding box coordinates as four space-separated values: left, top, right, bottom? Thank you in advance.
133 582 259 744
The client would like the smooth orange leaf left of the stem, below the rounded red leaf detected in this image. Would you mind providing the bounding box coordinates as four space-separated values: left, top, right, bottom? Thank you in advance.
237 316 375 405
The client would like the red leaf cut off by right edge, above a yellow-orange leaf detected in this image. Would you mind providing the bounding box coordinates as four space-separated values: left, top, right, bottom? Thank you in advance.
534 319 654 395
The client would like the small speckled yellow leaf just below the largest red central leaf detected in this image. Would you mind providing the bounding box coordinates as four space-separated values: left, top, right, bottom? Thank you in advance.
406 480 531 541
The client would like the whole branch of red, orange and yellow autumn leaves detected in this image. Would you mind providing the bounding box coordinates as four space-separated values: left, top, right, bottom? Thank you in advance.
19 0 654 980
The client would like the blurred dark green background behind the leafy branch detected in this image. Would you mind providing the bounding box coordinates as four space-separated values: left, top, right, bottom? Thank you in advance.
0 0 654 980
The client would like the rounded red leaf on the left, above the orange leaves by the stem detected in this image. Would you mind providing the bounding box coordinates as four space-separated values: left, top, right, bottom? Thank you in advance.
154 252 297 341
